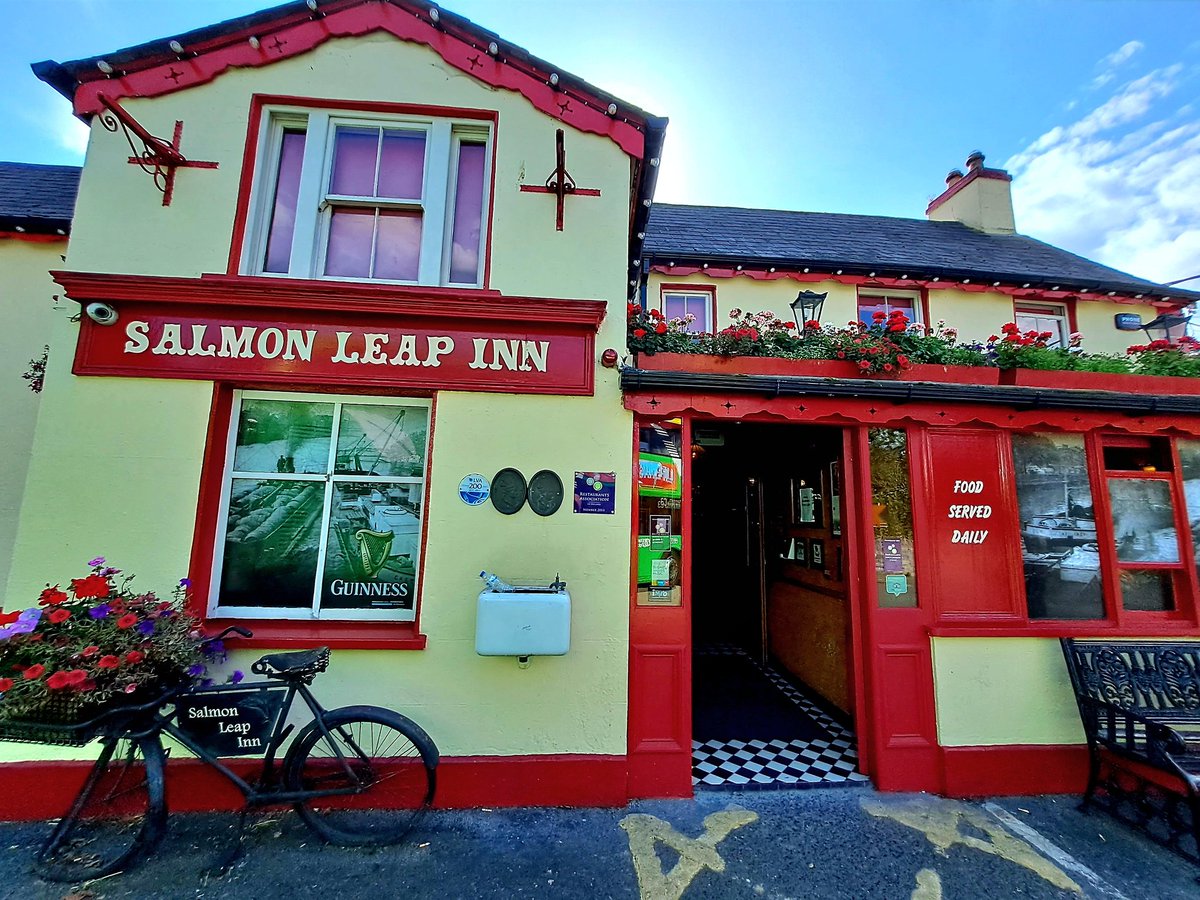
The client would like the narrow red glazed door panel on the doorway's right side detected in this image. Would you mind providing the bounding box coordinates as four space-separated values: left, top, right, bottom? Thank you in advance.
847 428 941 791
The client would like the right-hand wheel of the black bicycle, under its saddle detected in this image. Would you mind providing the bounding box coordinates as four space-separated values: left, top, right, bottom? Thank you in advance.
283 707 438 846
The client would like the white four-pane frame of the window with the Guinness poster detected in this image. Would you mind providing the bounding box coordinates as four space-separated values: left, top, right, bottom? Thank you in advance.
208 390 433 622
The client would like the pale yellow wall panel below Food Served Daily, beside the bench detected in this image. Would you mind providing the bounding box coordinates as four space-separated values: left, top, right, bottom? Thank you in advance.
932 637 1084 746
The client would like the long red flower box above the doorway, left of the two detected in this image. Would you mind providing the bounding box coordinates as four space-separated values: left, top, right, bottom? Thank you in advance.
638 353 998 384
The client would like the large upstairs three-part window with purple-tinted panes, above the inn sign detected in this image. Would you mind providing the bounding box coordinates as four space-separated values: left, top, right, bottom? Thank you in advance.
245 109 491 287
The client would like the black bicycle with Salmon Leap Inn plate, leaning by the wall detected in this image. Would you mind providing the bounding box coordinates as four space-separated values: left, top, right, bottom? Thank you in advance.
6 626 439 881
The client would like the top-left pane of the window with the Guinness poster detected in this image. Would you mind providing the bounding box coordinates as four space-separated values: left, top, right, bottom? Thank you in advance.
233 398 334 474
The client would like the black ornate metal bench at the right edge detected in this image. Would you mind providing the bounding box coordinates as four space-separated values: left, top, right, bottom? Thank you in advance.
1062 637 1200 863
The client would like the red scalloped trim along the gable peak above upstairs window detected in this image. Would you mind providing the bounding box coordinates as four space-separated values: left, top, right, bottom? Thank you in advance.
74 0 646 160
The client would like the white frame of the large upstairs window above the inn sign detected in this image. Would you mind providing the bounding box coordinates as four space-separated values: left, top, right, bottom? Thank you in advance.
241 107 494 288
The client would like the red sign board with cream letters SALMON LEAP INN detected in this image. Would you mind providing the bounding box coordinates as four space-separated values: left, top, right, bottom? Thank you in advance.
73 297 595 395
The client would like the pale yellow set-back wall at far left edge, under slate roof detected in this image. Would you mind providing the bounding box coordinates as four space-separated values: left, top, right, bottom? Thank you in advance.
0 238 67 607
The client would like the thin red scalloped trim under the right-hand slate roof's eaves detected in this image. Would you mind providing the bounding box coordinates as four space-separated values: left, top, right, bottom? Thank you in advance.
650 265 1187 311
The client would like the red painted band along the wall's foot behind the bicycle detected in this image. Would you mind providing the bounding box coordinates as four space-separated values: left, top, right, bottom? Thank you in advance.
0 754 626 822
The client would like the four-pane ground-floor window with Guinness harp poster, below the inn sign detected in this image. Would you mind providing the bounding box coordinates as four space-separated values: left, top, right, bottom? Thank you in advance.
211 391 430 622
